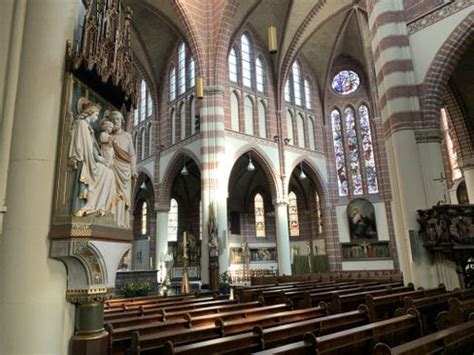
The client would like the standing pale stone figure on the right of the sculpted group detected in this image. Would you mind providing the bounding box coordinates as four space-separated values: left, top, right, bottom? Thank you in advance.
109 111 137 228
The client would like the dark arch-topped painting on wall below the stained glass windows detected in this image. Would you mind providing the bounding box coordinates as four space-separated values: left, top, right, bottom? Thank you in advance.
347 198 377 242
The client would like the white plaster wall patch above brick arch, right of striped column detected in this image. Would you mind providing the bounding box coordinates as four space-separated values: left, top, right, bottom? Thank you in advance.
409 6 474 84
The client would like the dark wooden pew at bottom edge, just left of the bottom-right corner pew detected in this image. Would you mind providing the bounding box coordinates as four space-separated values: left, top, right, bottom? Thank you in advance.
255 310 422 355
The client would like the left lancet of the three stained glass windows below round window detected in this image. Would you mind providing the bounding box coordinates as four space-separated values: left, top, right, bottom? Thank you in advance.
331 110 349 196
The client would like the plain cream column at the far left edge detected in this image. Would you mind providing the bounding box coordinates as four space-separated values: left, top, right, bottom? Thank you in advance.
0 0 79 355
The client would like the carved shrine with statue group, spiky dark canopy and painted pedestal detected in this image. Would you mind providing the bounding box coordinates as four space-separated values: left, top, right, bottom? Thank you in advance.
49 0 137 354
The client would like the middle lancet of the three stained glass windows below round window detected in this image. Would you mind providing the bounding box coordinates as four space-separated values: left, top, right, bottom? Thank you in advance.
344 107 364 195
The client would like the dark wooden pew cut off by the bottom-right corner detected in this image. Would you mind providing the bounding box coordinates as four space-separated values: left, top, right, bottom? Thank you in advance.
373 320 474 355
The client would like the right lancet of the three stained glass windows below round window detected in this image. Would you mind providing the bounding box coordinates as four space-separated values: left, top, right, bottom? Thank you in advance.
359 105 379 194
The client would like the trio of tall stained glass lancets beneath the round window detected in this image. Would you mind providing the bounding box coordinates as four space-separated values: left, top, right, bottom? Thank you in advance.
331 105 379 196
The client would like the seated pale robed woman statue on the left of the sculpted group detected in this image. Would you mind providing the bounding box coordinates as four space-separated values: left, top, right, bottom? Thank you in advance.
68 98 117 216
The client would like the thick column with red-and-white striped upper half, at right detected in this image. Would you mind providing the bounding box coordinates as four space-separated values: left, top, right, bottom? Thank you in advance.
367 0 456 287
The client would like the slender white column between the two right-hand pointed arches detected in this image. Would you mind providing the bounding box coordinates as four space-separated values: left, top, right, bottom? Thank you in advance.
275 201 291 275
